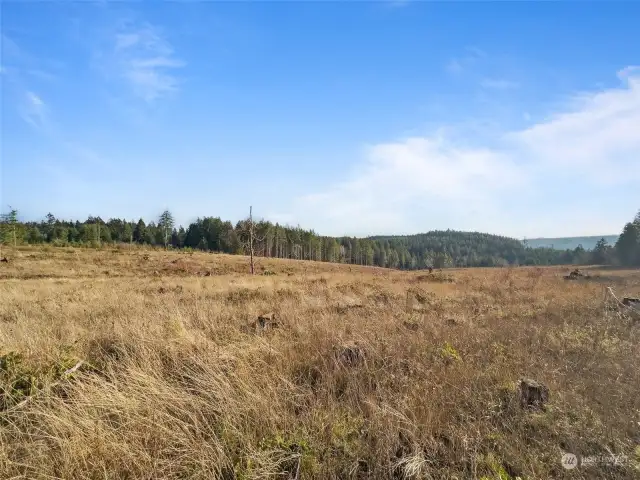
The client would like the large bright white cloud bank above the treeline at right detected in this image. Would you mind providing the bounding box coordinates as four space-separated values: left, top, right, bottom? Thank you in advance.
282 69 640 236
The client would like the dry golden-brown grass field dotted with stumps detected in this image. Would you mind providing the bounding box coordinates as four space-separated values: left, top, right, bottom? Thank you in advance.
0 247 640 480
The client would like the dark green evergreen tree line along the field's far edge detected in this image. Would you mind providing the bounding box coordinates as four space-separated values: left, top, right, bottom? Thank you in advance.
0 210 640 270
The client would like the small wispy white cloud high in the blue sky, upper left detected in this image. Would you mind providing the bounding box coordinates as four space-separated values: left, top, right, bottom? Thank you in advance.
111 24 185 103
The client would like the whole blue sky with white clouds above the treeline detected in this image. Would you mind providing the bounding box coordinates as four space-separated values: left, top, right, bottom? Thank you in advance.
0 0 640 238
